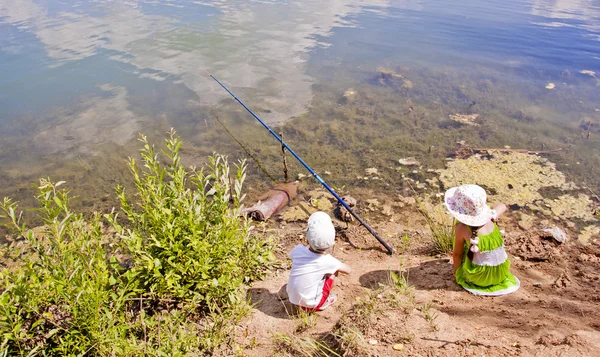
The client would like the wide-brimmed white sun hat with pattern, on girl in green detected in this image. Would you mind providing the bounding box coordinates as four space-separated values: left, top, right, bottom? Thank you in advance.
444 185 496 227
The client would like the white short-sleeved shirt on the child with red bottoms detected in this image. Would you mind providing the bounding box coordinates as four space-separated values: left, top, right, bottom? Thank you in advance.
286 244 342 308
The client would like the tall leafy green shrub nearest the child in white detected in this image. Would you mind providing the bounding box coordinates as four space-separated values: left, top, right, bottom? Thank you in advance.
111 131 274 307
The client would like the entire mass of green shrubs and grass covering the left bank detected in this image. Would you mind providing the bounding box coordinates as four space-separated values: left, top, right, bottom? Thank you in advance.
0 132 272 356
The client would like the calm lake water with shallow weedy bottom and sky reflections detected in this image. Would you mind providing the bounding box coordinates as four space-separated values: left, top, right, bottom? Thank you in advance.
0 0 600 213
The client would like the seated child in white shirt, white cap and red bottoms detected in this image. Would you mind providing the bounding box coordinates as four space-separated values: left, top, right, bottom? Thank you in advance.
286 212 352 311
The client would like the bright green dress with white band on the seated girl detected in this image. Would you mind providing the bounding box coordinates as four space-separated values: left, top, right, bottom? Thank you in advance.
456 224 520 296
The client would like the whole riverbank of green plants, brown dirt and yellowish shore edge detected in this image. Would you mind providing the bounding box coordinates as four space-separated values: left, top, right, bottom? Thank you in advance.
2 133 600 357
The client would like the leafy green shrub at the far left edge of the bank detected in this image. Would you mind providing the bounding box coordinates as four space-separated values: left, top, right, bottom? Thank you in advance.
0 180 132 356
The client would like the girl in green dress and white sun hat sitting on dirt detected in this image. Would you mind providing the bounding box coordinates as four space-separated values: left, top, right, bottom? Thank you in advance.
444 185 520 296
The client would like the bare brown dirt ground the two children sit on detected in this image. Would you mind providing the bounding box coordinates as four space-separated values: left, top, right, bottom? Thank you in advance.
238 196 600 357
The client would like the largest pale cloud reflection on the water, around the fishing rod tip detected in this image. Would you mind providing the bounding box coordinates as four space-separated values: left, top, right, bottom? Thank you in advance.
0 0 388 126
